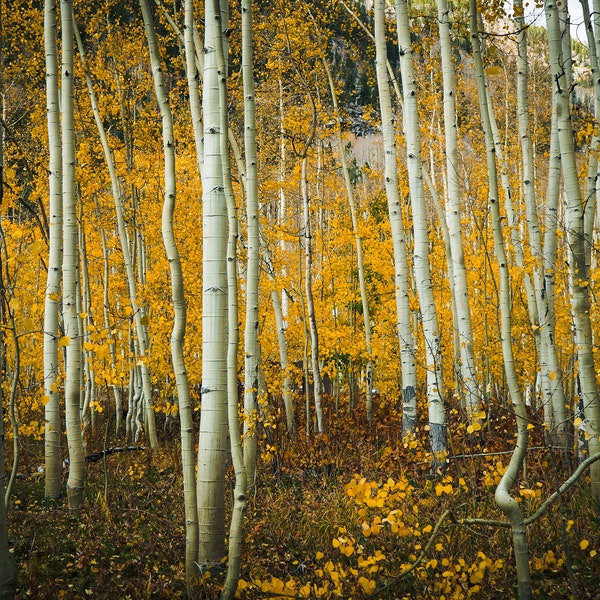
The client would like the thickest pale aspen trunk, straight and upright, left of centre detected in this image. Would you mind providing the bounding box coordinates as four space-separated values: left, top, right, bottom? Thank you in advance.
197 0 228 567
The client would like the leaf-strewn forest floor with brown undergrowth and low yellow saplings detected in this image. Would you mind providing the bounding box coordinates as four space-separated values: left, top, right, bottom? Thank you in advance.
9 398 600 600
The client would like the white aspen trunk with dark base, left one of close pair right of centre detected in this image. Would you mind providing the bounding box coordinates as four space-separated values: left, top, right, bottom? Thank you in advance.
374 0 417 435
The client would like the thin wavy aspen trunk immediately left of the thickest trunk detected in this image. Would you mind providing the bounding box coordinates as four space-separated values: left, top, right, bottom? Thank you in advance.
140 0 198 584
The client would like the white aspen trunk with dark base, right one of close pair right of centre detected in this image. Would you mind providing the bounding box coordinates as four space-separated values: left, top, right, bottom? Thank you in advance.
395 0 448 464
